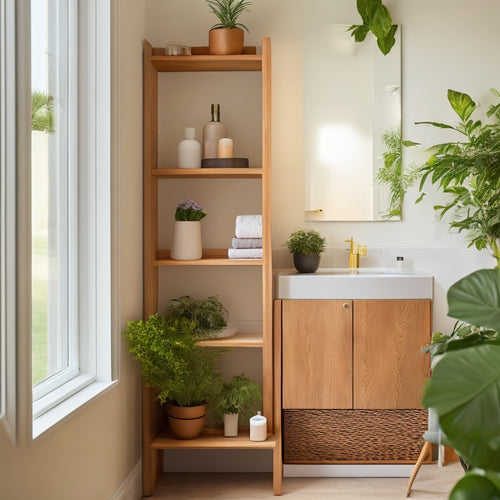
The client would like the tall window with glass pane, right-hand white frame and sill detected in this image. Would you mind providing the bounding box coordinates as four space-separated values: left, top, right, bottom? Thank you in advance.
31 0 112 436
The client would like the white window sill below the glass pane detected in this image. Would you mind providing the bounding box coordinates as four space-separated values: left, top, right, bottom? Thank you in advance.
32 381 117 439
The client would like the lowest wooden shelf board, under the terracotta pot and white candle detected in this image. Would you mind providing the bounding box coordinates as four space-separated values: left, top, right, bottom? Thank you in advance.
151 429 279 450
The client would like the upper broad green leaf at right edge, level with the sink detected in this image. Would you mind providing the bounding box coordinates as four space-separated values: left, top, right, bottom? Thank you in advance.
448 268 500 330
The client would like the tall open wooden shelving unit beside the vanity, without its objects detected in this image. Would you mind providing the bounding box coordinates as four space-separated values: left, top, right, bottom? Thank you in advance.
143 38 282 496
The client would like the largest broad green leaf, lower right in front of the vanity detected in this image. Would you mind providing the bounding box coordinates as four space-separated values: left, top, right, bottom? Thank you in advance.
423 344 500 472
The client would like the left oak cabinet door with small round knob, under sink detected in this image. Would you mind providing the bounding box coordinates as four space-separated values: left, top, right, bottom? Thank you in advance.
282 300 352 409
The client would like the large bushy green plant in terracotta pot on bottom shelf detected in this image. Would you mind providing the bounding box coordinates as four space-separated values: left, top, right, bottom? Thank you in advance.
124 313 223 439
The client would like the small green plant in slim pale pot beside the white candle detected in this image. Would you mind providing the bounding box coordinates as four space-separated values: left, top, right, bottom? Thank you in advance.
215 375 262 437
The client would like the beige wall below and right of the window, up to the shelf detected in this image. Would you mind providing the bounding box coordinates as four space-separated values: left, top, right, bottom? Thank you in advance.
0 0 144 500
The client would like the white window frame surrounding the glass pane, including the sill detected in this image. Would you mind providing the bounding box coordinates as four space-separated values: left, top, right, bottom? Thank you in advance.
0 0 114 442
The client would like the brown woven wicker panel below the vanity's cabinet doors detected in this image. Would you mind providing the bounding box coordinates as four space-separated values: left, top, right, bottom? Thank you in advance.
283 409 427 464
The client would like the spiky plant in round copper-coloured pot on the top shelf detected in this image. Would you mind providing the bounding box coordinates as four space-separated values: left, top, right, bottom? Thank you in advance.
207 0 252 55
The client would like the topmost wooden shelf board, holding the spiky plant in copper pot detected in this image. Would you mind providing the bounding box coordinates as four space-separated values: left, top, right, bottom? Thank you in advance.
151 54 262 71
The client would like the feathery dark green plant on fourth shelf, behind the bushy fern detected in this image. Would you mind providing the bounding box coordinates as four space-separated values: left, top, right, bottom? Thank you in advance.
164 295 227 338
